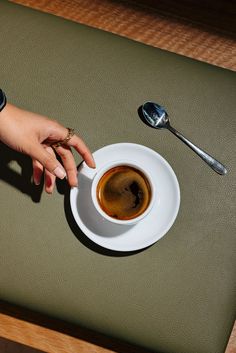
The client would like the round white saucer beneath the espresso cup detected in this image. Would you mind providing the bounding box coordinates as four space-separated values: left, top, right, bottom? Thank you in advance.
70 143 180 251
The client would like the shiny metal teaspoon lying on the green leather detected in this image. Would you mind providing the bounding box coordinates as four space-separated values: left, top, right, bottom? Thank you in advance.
142 102 227 175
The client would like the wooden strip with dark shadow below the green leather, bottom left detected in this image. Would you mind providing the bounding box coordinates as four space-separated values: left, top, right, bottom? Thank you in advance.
0 301 150 353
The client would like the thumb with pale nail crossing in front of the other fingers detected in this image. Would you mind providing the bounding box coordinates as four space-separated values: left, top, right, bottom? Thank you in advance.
29 144 66 179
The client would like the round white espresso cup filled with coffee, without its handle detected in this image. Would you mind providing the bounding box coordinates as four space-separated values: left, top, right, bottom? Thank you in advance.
91 160 156 225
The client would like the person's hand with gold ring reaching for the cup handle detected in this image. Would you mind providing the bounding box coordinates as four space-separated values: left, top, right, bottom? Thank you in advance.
0 103 95 193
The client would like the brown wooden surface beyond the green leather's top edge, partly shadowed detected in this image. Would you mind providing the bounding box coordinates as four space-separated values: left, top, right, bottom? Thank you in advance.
9 0 236 71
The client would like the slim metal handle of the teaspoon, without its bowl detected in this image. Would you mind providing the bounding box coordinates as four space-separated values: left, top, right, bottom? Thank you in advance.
168 125 227 175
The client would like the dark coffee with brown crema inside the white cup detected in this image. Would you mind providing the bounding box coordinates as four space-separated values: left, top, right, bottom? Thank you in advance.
96 165 151 220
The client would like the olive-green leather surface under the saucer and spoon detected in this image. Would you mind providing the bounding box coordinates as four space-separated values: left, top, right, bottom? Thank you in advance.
0 1 236 353
